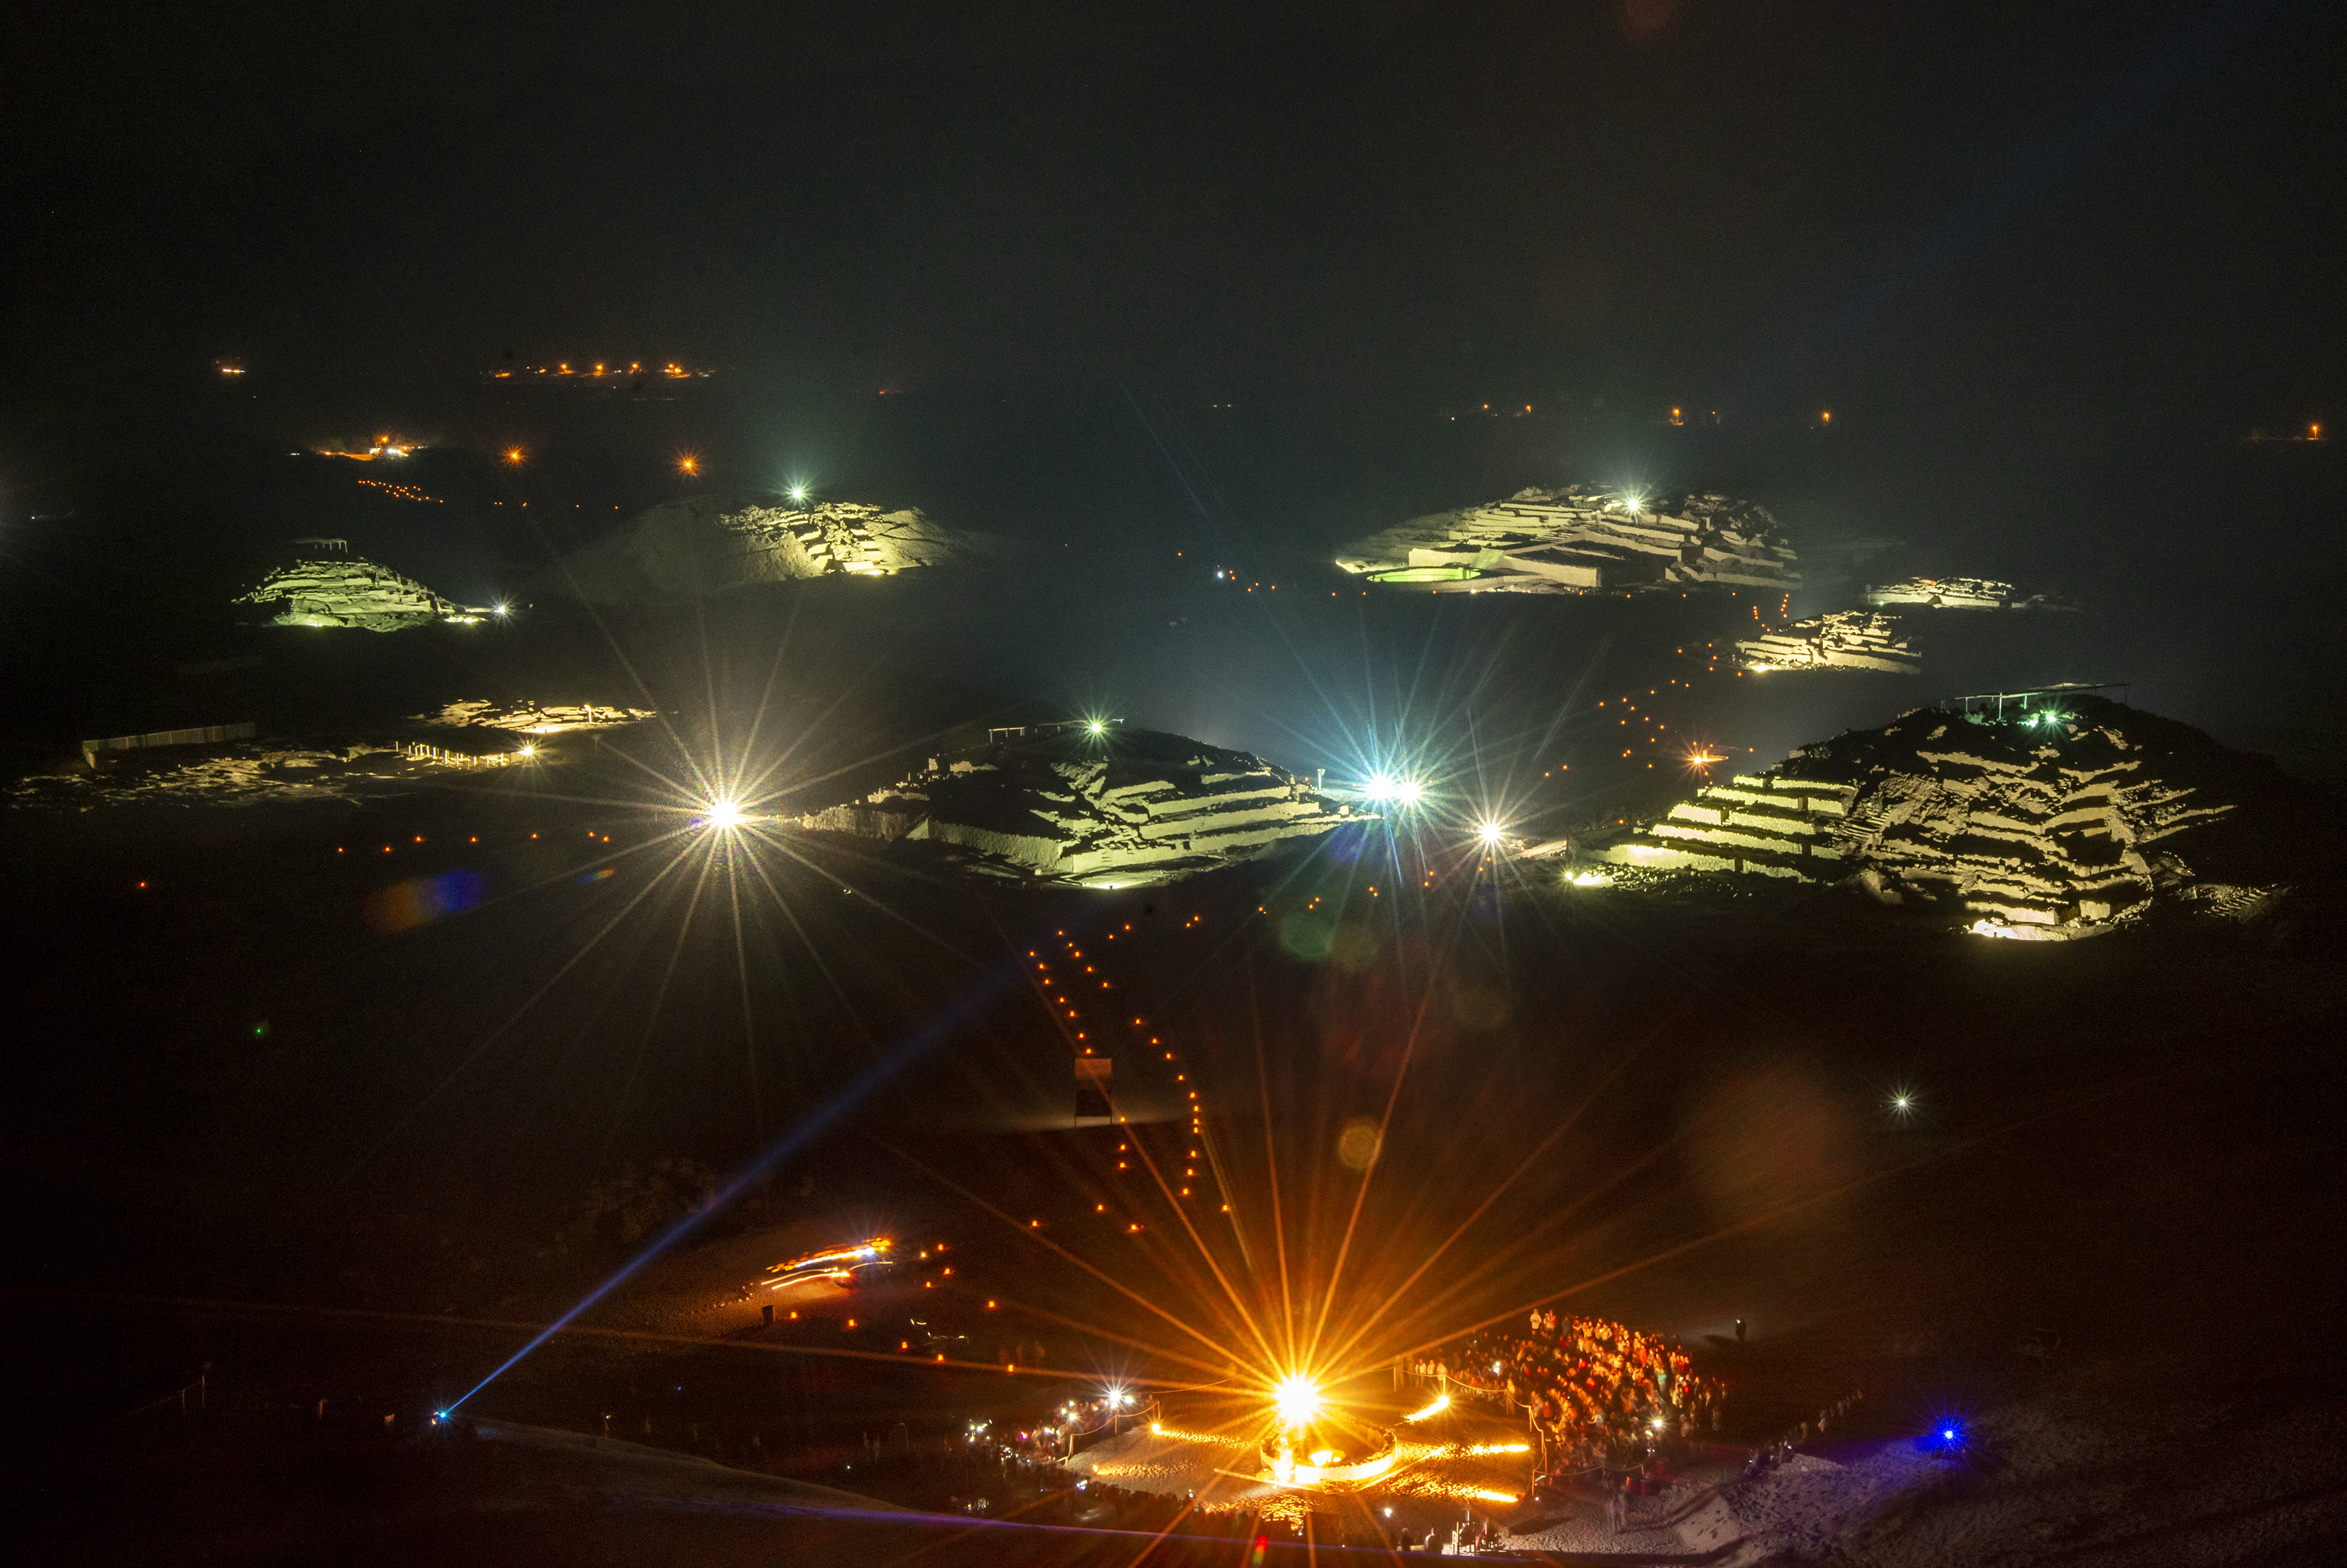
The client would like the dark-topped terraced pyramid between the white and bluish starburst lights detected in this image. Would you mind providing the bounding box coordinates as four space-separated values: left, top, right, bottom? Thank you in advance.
788 725 1366 887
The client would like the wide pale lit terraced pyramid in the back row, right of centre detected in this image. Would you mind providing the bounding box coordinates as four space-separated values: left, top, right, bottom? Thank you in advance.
1335 486 1800 594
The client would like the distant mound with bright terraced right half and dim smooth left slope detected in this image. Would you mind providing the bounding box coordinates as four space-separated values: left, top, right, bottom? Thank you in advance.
531 496 998 603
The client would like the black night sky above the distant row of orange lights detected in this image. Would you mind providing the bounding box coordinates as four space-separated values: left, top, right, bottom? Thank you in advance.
5 0 2347 423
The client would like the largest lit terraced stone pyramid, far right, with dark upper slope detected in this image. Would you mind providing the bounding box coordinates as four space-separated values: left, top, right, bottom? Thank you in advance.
1594 697 2253 937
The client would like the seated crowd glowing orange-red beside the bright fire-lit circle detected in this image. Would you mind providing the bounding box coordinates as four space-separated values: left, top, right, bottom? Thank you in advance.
1410 1310 1725 1474
